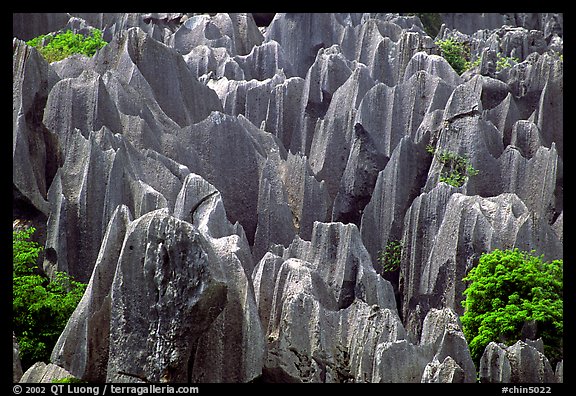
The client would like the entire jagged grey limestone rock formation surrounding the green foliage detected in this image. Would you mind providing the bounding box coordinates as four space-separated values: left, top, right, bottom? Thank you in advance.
13 13 564 382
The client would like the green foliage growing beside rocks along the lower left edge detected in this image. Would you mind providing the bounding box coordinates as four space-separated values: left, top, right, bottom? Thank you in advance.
12 227 86 370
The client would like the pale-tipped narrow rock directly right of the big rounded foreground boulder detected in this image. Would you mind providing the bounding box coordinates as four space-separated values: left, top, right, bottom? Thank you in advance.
188 234 265 383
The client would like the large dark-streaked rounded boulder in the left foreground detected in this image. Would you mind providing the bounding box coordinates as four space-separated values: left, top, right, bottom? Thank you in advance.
106 209 227 382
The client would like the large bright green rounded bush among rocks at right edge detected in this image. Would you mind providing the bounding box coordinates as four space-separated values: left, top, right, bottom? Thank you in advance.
460 248 563 365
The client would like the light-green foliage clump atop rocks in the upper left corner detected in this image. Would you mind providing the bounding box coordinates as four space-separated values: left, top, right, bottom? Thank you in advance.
26 29 107 63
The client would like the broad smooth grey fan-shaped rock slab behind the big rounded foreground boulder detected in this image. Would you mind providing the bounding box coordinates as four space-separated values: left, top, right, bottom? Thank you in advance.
169 112 270 244
